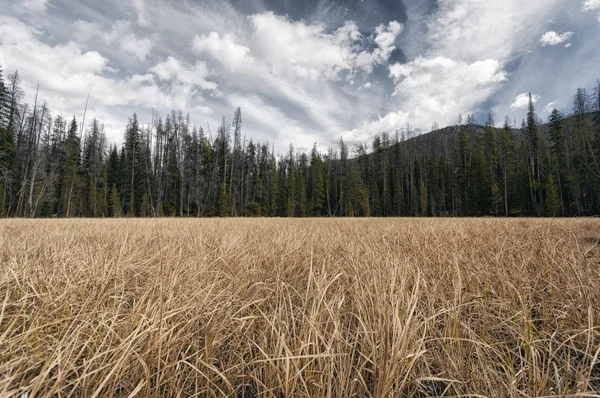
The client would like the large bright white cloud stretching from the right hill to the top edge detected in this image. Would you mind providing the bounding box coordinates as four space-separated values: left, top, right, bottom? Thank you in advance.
347 0 554 141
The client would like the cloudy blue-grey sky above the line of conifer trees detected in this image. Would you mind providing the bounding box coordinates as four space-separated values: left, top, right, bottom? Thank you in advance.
0 0 600 153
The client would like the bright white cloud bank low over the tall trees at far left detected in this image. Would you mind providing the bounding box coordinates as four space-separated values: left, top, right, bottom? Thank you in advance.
0 17 216 145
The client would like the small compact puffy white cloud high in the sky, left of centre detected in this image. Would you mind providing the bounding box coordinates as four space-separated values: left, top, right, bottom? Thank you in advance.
192 32 254 72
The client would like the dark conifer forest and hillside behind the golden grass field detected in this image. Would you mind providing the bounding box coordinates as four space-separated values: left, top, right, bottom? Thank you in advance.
0 64 600 217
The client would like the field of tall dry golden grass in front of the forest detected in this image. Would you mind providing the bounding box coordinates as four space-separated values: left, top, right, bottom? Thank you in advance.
0 219 600 398
